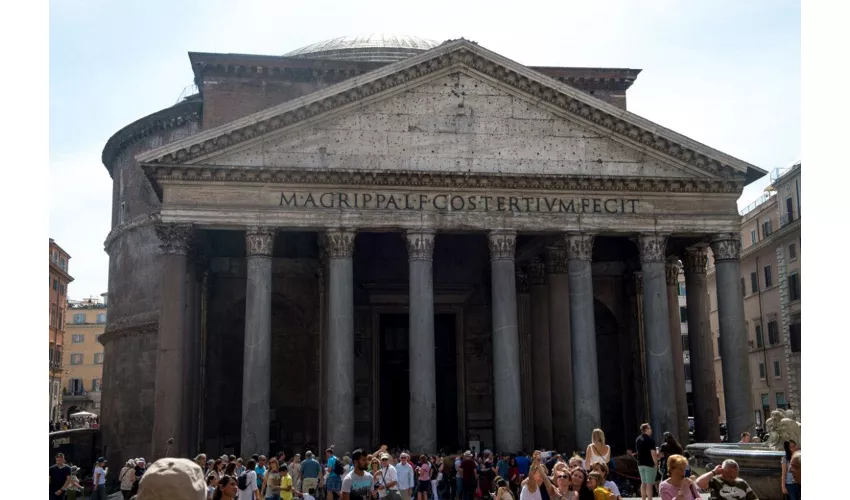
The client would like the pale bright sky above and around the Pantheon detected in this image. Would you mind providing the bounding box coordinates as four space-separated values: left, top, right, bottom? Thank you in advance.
49 0 800 298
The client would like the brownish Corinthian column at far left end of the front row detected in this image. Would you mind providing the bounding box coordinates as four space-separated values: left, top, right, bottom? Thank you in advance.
152 224 194 460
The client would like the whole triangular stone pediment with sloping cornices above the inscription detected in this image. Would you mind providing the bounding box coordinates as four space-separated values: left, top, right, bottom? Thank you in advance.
137 40 763 186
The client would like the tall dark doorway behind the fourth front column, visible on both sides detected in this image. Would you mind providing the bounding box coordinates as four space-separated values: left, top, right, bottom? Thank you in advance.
378 314 459 451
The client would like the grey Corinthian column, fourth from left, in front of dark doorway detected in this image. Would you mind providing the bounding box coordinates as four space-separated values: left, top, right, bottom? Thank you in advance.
407 231 437 453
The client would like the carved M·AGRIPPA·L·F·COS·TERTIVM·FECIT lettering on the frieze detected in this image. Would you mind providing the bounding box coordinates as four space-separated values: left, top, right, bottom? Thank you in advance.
279 191 640 214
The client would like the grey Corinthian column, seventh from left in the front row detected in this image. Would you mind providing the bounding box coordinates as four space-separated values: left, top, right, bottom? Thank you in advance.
638 234 677 440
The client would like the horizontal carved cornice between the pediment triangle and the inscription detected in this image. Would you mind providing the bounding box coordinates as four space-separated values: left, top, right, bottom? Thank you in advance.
143 164 744 195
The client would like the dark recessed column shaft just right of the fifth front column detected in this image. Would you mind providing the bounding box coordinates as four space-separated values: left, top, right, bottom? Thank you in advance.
528 259 554 450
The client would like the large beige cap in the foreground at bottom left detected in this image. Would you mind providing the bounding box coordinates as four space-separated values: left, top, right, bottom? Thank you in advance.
137 458 207 500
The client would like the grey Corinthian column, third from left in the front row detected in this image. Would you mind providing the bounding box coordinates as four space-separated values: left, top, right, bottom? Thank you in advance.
326 229 356 450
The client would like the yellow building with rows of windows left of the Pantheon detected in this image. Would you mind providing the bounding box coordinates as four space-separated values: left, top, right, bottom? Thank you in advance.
62 293 106 419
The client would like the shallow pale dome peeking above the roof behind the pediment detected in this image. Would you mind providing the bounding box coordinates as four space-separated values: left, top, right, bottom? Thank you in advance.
283 33 440 62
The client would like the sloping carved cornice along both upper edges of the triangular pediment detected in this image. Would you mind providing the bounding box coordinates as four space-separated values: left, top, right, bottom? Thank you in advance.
136 39 765 179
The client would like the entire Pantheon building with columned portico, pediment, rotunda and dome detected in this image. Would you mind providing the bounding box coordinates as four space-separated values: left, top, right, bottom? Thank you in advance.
101 35 765 463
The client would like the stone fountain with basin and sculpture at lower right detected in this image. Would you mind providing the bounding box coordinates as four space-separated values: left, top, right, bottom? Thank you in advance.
686 410 802 500
